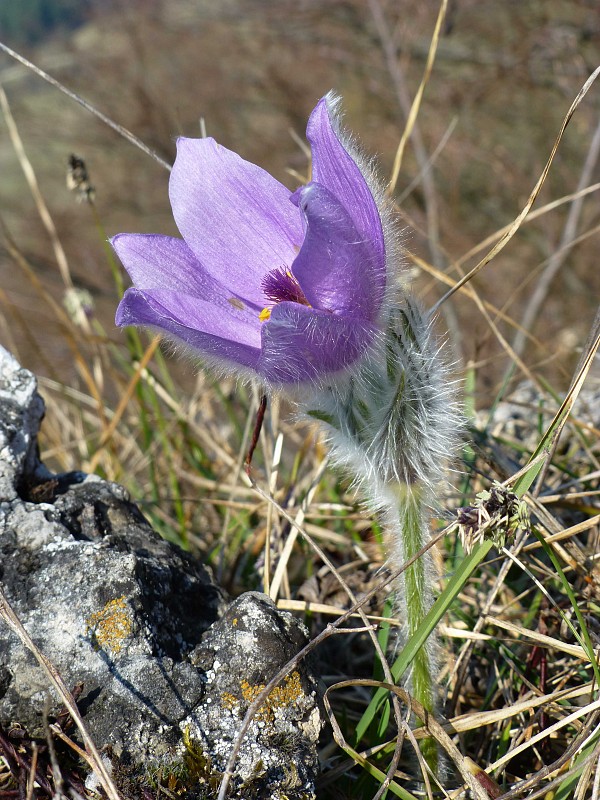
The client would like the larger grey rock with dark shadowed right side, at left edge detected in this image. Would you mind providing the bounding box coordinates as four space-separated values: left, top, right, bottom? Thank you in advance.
0 481 225 762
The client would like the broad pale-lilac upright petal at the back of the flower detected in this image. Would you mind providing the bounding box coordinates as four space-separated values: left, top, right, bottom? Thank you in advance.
169 138 303 305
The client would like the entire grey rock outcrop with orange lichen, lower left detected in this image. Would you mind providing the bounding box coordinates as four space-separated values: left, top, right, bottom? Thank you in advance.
0 348 321 800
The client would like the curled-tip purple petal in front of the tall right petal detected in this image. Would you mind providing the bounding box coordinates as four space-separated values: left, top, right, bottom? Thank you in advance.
292 183 385 321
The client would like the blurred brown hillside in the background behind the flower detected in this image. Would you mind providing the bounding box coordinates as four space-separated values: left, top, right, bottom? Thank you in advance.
0 0 600 404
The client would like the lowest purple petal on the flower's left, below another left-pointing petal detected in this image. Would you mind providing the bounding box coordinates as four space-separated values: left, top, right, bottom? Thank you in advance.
115 288 260 369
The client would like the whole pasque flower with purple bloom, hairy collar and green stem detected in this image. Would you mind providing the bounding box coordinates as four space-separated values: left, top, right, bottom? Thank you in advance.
112 92 461 769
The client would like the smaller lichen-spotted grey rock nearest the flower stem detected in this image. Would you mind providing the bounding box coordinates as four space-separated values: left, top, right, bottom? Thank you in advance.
181 592 322 800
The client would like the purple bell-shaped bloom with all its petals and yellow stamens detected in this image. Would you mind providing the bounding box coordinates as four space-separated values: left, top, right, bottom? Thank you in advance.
112 97 386 385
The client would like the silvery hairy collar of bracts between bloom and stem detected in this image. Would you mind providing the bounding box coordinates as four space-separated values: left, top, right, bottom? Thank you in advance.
304 295 462 507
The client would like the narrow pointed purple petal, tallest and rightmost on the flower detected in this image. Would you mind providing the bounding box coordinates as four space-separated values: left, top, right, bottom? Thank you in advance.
306 96 385 279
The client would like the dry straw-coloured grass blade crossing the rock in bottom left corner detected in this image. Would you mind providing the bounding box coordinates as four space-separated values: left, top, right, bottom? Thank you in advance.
0 587 121 800
